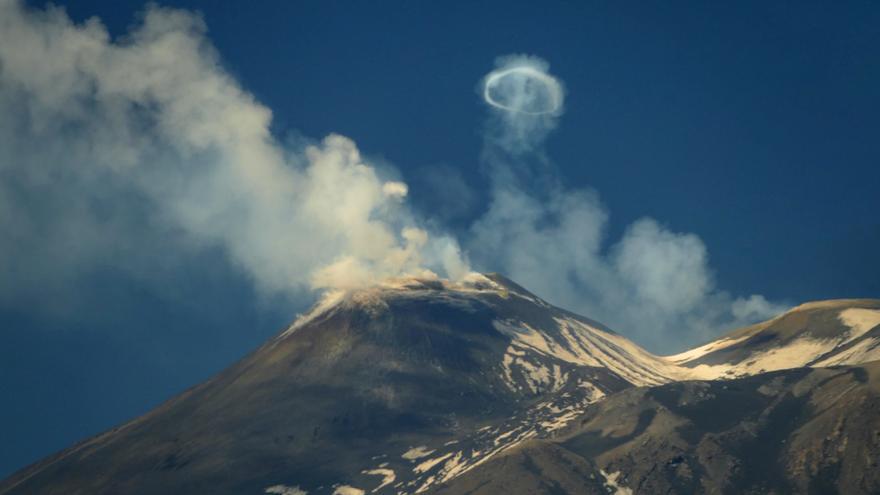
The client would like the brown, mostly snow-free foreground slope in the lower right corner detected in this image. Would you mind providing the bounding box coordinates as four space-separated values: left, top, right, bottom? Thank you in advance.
436 362 880 495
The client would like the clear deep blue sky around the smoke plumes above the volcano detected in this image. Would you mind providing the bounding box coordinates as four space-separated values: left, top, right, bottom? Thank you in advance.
0 0 880 476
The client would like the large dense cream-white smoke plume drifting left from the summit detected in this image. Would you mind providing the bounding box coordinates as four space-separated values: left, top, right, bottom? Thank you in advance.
0 0 467 310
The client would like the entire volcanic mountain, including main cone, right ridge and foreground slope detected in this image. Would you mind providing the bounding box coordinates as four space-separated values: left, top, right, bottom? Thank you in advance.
0 274 880 495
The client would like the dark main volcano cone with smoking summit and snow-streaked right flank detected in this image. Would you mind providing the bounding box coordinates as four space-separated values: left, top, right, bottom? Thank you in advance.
0 275 679 494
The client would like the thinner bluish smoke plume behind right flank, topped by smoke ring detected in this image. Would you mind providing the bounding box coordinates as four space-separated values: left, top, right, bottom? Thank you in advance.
467 56 785 352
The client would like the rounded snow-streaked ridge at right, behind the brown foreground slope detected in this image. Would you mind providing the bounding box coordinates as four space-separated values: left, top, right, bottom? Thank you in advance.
668 299 880 379
